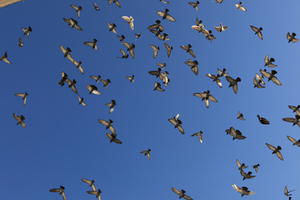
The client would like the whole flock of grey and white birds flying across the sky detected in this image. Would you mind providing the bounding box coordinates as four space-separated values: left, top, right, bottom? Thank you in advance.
0 0 300 200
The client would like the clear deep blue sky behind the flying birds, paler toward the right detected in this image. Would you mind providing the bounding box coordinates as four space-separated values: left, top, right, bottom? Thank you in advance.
0 0 300 200
